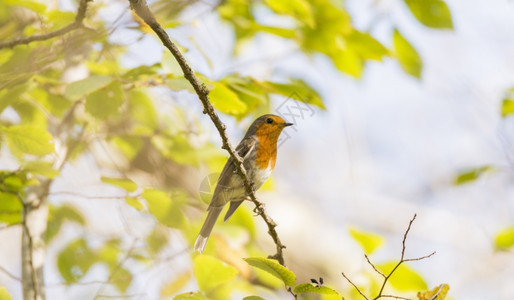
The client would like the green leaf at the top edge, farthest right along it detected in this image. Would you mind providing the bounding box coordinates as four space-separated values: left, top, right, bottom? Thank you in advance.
405 0 453 29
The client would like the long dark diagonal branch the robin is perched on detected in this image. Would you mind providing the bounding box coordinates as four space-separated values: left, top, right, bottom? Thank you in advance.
129 0 285 265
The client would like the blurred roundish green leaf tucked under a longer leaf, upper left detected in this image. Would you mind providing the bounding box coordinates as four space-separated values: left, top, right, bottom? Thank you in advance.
86 81 124 119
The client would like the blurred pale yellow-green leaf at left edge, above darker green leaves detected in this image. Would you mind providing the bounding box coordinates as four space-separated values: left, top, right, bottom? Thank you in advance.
1 125 54 156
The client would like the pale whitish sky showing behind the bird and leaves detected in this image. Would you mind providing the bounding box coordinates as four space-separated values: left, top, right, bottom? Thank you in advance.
0 0 514 300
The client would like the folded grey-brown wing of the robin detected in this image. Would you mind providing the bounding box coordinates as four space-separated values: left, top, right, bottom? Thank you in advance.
209 137 257 207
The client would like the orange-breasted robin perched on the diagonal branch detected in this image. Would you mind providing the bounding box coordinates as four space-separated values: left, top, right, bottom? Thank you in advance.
194 114 293 253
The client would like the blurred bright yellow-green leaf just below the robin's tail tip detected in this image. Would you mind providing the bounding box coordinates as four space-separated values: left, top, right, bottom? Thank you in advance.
193 255 237 293
